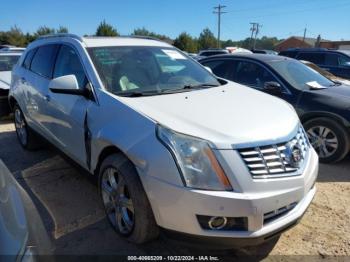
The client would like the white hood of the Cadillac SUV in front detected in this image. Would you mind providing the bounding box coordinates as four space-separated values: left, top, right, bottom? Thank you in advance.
118 82 299 149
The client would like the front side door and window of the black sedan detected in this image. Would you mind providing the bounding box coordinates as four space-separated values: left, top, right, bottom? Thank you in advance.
232 59 297 106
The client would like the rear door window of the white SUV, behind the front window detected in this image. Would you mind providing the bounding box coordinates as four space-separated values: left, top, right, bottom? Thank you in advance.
30 45 58 78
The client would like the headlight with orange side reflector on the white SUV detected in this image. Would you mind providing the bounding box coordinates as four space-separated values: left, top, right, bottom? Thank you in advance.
157 126 232 190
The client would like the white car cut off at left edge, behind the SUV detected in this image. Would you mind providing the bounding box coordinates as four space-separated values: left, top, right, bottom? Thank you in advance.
0 48 22 117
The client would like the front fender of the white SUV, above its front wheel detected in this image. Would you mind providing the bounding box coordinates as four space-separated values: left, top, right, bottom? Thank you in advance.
88 91 183 185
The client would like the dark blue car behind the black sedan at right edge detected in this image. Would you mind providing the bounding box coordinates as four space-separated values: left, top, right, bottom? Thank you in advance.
279 48 350 79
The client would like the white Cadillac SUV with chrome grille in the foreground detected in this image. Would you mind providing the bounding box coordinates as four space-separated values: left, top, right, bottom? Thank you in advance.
9 35 318 245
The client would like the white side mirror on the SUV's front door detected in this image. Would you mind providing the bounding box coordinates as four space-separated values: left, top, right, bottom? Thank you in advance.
49 75 86 96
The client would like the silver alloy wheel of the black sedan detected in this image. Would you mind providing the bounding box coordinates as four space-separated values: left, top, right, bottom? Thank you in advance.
307 126 339 158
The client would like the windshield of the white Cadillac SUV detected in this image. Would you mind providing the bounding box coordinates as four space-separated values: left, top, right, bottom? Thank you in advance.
89 46 220 95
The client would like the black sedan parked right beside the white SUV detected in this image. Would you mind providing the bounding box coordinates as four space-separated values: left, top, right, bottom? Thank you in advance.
199 54 350 163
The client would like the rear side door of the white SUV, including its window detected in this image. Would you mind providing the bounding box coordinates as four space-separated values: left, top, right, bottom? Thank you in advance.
21 44 58 136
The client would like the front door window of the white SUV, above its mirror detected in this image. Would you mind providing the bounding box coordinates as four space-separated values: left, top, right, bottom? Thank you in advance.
53 45 87 88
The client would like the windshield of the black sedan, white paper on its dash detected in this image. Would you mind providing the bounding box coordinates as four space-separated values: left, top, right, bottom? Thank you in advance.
269 60 334 90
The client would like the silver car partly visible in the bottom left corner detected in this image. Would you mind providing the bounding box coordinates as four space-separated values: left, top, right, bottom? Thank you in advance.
0 160 52 261
